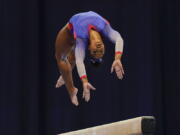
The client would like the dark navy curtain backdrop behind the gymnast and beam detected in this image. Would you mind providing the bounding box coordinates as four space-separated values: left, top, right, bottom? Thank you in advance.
0 0 180 135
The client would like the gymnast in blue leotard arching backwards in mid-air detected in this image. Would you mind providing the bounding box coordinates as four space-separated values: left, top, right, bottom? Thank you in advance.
55 11 124 106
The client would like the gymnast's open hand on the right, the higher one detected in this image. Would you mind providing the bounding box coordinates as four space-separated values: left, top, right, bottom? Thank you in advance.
111 59 124 80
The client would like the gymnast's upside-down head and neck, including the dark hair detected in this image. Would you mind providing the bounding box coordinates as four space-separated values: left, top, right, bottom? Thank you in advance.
89 29 105 66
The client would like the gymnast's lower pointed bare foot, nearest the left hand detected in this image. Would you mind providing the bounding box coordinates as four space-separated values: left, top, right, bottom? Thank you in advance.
69 87 79 106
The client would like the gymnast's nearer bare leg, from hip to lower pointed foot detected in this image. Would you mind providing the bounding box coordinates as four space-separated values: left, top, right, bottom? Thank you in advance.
55 25 78 106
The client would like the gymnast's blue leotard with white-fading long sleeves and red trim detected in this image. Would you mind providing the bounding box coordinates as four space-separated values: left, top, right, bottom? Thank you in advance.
68 11 123 77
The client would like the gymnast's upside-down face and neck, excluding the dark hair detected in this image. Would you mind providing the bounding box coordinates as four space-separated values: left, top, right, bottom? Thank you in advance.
89 30 105 59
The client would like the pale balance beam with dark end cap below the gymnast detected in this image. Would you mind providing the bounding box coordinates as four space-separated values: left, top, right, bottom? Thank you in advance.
59 116 156 135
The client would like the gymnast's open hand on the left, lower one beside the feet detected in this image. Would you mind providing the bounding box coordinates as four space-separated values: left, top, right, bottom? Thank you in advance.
83 82 96 102
